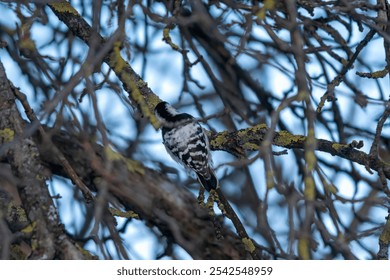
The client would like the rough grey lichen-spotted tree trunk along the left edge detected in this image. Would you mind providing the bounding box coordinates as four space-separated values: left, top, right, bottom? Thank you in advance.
0 62 88 259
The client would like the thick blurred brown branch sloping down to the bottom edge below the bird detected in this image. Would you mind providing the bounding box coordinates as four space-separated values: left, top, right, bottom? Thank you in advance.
34 130 258 259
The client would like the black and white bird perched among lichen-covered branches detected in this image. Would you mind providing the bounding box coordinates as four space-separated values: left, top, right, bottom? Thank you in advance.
154 102 218 191
